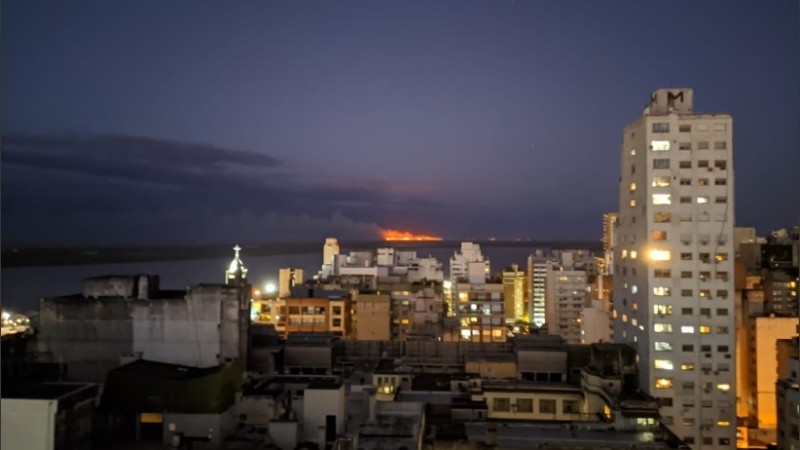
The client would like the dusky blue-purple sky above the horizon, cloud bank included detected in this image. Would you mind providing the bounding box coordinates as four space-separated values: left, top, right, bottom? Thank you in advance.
2 0 800 244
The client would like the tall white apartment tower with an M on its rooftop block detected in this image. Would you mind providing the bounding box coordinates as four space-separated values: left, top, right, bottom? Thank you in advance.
612 89 736 449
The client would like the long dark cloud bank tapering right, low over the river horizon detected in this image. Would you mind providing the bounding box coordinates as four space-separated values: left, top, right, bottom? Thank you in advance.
2 134 444 244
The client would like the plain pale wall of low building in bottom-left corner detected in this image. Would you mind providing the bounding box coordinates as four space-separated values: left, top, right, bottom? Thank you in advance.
0 398 58 450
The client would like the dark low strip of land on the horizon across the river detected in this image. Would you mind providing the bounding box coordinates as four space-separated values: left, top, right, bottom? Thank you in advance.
2 240 602 268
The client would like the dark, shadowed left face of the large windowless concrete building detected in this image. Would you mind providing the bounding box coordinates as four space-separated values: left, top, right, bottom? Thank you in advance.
37 298 133 383
